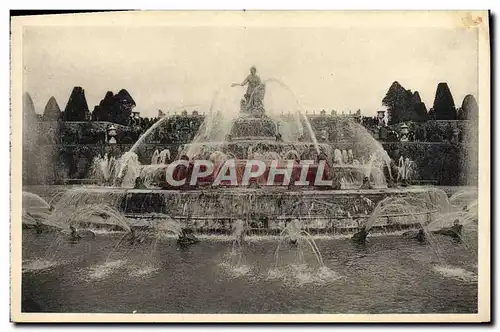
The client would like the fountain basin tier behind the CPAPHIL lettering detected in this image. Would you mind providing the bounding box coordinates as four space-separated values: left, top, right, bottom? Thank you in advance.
126 159 378 190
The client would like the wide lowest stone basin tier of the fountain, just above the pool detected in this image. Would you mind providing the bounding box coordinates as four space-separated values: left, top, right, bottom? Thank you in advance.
42 187 438 235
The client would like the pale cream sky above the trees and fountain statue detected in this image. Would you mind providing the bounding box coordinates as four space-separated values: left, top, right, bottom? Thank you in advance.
23 26 478 116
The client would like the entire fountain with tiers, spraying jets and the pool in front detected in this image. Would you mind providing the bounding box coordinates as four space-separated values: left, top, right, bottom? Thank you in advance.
22 66 478 314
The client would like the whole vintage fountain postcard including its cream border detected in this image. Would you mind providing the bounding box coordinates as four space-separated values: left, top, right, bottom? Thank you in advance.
10 10 491 322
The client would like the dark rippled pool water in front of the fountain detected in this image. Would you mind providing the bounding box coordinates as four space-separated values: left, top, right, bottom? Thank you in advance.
22 230 477 313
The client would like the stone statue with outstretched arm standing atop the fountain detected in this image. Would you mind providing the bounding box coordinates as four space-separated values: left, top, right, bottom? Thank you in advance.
231 66 266 116
